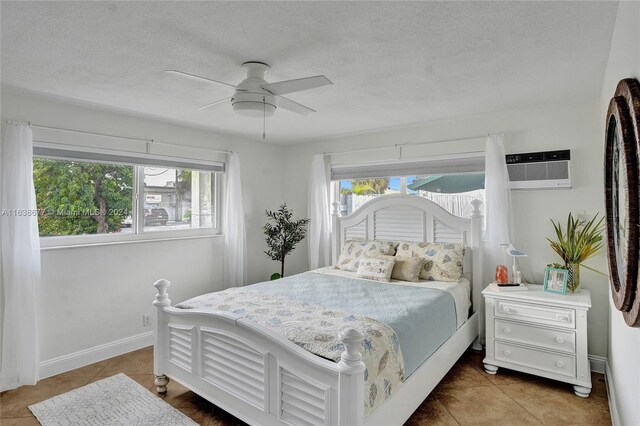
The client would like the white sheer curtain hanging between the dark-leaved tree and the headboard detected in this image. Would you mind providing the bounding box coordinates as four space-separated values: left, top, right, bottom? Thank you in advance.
309 154 331 269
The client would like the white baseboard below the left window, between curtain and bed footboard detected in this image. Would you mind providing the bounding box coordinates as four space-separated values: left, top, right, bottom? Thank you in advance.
40 331 153 379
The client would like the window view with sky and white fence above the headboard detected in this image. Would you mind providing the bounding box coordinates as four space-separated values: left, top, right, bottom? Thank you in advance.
334 173 484 218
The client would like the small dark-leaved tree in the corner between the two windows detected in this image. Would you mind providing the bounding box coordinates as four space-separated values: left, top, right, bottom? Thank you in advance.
263 204 310 280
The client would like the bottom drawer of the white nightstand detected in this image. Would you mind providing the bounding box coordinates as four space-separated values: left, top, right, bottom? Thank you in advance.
495 342 576 377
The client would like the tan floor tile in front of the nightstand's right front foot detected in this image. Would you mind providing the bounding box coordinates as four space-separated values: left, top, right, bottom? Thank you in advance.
498 381 611 425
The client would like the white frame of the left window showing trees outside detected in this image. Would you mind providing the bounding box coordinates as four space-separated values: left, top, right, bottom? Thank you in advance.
33 156 224 249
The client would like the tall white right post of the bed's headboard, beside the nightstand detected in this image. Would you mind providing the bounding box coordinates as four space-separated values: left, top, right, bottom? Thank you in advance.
471 200 484 350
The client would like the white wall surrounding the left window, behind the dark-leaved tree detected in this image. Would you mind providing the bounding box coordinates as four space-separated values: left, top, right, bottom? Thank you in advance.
1 88 283 361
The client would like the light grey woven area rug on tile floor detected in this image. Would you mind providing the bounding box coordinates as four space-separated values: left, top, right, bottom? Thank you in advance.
29 373 197 426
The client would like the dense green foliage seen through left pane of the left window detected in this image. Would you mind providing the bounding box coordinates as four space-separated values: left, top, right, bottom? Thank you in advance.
33 158 133 235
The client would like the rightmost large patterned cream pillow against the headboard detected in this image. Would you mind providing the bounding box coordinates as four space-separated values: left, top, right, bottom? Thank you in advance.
413 243 464 281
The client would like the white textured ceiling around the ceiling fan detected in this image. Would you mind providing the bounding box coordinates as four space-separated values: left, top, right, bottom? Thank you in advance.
0 1 617 143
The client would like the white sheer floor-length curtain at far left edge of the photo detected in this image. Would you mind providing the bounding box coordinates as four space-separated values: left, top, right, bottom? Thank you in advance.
0 122 40 391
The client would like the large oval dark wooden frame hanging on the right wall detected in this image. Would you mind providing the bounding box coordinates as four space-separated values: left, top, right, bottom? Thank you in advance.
604 79 640 327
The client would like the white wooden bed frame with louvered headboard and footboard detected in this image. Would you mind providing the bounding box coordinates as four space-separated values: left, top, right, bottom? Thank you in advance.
153 195 484 426
